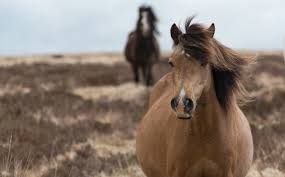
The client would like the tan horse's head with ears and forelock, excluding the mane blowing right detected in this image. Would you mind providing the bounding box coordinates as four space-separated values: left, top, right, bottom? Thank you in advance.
169 19 215 119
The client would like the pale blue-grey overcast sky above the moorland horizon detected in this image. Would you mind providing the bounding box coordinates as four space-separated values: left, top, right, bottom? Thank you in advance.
0 0 285 55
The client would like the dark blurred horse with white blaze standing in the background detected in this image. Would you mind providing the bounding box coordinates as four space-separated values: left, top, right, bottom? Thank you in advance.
125 6 159 85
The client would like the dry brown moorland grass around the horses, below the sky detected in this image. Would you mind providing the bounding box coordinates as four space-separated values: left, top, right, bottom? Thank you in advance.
0 52 285 177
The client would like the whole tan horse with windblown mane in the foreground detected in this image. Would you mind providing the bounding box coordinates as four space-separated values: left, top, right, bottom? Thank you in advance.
136 18 253 177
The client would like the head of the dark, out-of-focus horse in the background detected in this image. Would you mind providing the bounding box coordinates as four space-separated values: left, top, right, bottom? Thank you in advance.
137 6 157 37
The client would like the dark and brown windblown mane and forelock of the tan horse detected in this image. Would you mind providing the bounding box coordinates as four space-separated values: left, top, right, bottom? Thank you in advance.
179 17 252 111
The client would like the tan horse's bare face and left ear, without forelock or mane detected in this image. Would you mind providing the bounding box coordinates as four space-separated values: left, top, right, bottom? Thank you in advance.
169 22 211 119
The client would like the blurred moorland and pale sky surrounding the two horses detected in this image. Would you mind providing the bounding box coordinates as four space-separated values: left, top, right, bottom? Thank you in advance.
0 0 285 177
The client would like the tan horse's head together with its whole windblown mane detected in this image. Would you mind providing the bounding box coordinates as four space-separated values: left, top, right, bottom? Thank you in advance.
169 17 254 118
